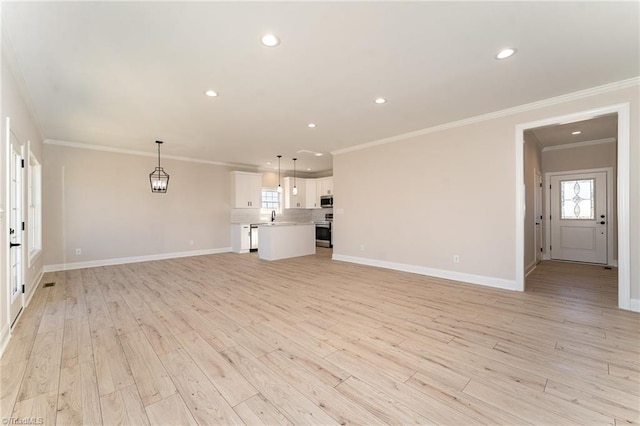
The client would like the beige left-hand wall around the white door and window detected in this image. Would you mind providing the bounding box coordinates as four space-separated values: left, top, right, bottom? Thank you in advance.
0 49 43 351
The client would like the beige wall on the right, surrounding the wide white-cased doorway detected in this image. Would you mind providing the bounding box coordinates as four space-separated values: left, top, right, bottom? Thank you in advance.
333 83 640 299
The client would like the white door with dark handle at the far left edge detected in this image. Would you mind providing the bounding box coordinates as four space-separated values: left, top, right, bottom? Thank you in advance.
7 126 24 327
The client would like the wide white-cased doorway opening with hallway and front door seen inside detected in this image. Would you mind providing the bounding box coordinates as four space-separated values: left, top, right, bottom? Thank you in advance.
516 103 631 309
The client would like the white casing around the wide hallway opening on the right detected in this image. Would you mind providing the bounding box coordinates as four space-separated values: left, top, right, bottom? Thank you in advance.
514 102 638 310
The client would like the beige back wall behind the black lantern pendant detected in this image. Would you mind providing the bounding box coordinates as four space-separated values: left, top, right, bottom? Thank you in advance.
43 141 231 270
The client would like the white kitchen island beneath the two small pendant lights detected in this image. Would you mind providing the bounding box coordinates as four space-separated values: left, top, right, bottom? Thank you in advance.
258 222 316 260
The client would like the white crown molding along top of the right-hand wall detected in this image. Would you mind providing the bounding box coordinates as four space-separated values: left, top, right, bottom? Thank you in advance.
331 77 640 155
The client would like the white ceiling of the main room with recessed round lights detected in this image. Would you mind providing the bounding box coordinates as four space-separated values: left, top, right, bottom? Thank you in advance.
2 1 640 172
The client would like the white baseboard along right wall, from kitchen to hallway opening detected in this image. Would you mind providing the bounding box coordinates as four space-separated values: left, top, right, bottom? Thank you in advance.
331 254 518 291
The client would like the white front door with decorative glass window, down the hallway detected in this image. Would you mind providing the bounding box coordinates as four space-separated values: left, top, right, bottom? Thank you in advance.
551 172 609 264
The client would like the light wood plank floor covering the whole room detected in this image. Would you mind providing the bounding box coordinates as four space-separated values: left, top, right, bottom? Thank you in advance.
0 250 640 425
